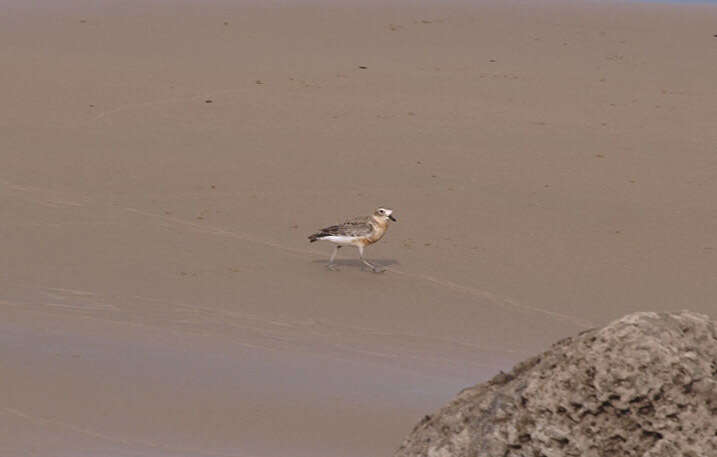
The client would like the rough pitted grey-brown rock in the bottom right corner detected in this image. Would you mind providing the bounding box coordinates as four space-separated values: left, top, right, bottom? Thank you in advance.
395 311 717 457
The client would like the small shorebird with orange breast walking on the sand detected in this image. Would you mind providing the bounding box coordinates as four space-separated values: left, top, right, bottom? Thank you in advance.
309 208 396 273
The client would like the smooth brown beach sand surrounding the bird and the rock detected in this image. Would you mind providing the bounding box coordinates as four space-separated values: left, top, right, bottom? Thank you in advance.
0 0 717 457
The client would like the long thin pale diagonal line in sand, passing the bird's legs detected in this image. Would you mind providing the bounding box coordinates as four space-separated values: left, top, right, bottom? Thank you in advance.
125 208 595 329
